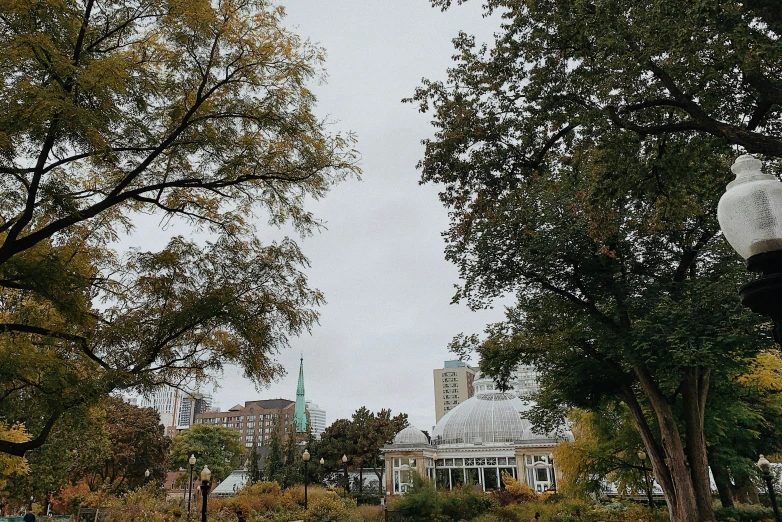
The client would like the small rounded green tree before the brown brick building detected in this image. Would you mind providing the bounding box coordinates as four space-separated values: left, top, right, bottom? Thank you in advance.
171 424 246 481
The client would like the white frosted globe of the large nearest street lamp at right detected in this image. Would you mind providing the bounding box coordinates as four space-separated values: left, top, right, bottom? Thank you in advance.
717 154 782 259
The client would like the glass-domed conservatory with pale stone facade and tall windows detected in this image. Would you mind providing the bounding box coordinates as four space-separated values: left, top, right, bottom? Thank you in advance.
383 372 573 495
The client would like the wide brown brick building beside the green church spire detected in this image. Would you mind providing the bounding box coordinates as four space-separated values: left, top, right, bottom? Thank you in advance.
195 399 296 448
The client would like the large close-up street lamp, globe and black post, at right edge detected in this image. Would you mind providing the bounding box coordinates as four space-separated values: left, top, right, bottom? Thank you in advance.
717 154 782 346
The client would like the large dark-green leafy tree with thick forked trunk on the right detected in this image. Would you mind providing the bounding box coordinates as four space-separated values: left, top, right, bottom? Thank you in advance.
413 0 782 521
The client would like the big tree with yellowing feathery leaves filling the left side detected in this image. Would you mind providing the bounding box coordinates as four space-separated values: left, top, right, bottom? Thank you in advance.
0 0 358 455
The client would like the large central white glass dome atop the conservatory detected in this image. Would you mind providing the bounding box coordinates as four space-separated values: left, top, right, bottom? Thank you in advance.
432 377 538 445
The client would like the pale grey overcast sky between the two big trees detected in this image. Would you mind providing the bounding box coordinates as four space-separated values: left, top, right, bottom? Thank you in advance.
130 0 502 430
